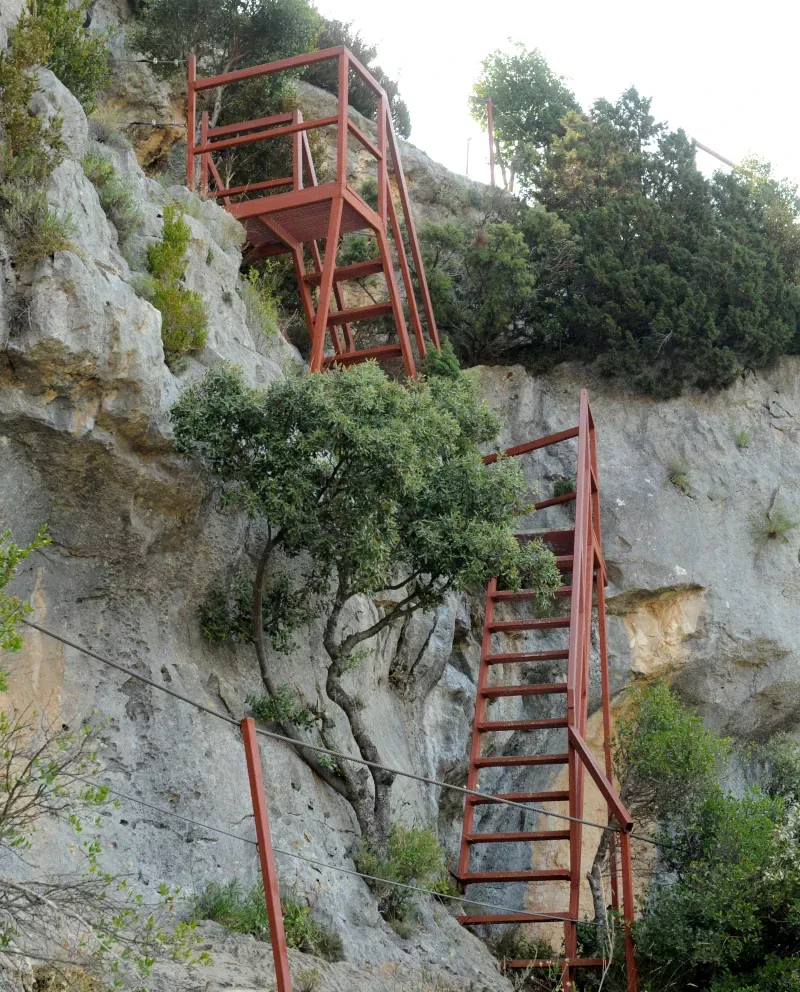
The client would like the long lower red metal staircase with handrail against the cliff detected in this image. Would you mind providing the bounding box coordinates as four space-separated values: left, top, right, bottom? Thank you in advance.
458 389 637 992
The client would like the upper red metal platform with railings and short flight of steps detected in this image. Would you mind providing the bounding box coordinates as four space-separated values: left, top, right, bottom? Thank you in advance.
186 47 440 378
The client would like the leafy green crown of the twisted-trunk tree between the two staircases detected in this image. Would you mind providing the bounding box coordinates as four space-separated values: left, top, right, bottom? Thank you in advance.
173 363 559 607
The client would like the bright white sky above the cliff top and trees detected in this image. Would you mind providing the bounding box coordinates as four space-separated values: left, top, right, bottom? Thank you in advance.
317 0 800 188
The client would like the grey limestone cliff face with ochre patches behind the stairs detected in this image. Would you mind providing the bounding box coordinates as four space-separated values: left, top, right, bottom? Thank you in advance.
0 36 800 992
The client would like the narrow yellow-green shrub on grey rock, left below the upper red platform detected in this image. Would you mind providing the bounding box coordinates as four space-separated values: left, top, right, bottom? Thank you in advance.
147 203 208 364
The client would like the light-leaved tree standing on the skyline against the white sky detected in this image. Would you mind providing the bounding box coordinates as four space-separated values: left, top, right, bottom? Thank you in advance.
470 44 580 193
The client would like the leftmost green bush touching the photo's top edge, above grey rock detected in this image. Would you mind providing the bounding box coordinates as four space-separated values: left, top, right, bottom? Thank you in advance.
26 0 109 113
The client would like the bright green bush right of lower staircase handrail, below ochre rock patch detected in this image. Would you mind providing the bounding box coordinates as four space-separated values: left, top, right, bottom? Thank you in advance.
613 682 730 824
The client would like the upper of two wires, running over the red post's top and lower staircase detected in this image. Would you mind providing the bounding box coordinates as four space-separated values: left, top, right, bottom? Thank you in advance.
21 620 675 847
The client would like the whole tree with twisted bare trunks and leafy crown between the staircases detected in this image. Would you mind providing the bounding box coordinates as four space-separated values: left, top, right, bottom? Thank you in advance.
173 361 560 857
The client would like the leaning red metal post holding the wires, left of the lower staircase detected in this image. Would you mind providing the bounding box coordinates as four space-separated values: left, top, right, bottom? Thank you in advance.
241 717 292 992
